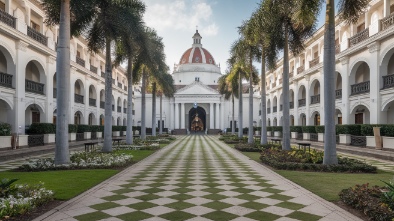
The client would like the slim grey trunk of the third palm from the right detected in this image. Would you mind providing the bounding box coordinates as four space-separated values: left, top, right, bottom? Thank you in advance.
260 48 268 145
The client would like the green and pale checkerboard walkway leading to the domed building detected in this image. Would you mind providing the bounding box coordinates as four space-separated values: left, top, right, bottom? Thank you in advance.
36 136 360 221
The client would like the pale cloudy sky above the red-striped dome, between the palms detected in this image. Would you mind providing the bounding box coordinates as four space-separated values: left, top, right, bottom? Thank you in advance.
144 0 323 73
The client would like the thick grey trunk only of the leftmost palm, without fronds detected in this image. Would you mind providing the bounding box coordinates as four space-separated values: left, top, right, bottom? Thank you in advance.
55 0 70 165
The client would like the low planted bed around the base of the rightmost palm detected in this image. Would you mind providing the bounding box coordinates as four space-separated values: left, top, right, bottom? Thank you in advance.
260 149 377 173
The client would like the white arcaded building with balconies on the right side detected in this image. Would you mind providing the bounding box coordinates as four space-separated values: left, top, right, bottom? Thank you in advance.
266 0 394 126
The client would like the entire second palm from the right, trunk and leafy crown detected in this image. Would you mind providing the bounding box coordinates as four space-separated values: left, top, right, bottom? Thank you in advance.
264 0 320 150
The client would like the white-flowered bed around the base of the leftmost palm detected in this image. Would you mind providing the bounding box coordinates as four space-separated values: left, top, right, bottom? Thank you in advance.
16 151 133 171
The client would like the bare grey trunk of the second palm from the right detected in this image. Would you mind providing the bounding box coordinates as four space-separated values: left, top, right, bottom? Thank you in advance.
282 27 291 150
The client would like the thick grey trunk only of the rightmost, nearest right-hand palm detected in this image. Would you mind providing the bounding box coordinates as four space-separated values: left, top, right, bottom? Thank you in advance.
323 0 338 165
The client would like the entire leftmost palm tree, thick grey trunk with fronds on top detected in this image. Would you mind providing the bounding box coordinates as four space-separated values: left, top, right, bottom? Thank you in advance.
42 0 96 165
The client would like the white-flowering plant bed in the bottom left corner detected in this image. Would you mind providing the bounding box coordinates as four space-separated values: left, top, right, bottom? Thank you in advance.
0 179 53 219
